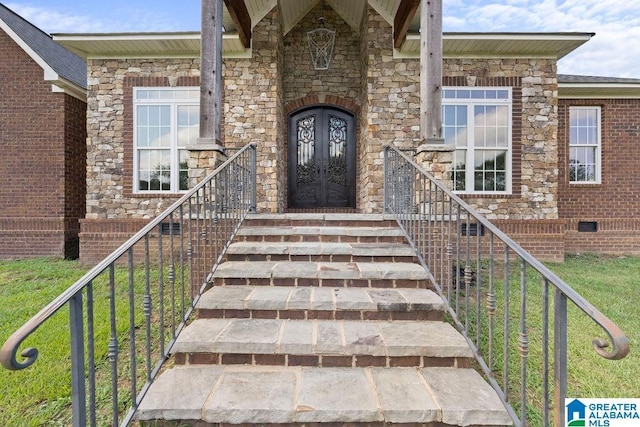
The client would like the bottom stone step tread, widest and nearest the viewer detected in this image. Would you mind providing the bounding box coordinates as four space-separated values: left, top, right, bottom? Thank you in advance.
136 366 512 426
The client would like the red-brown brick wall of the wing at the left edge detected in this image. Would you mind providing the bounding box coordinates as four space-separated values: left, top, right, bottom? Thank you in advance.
0 32 86 258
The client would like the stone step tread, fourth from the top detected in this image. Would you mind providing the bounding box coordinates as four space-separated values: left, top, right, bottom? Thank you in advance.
213 260 428 280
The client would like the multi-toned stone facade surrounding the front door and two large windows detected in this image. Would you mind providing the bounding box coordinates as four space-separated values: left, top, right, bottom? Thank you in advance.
83 7 558 262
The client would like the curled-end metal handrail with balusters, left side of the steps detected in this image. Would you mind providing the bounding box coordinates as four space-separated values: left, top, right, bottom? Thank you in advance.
0 143 256 424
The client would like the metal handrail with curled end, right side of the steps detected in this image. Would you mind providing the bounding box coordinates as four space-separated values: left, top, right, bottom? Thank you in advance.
384 145 629 425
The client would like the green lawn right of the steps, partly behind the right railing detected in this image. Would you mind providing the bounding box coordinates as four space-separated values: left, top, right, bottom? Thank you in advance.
452 255 640 426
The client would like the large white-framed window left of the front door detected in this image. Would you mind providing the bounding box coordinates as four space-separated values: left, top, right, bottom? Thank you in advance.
133 87 200 193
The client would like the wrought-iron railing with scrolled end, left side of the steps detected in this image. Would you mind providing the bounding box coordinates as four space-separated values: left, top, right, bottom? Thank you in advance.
0 144 256 426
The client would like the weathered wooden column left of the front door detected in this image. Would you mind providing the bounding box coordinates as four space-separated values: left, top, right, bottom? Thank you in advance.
197 0 223 151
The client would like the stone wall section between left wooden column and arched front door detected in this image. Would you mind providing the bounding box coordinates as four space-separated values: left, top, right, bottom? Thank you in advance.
223 7 286 212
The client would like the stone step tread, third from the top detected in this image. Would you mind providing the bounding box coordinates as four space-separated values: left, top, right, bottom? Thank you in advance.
227 242 415 256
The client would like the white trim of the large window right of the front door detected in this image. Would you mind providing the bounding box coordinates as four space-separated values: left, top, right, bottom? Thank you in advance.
442 86 513 196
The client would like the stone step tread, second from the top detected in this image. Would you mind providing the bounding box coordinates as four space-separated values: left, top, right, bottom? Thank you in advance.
238 225 404 237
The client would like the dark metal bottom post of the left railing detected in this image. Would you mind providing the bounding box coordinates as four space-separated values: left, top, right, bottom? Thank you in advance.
69 292 87 427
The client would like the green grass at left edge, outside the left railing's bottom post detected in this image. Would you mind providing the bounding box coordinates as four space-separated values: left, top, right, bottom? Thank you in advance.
0 259 86 426
